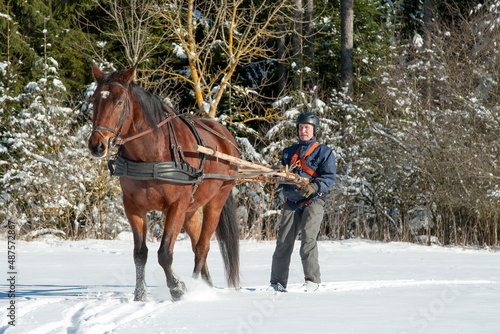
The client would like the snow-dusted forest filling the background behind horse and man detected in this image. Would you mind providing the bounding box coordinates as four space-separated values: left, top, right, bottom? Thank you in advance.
0 0 500 247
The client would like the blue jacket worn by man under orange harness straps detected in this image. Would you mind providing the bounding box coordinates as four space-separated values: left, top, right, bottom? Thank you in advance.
281 138 336 202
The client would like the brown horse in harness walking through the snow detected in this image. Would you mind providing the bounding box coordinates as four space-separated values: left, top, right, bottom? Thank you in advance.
88 65 239 301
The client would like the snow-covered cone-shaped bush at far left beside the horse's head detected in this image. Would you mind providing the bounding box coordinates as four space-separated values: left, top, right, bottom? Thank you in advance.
0 58 126 238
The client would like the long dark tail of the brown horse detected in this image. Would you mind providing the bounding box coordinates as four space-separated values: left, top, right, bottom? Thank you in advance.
215 192 240 289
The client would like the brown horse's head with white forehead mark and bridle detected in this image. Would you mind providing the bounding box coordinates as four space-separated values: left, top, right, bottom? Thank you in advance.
88 65 136 158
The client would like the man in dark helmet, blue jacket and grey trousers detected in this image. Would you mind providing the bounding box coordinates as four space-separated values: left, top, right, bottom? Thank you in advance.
270 112 336 292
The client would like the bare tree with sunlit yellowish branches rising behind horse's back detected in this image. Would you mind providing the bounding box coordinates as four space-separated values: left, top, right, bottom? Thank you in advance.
153 0 292 118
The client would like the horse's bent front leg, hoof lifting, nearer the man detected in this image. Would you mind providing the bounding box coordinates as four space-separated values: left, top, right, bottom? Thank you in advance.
158 212 186 301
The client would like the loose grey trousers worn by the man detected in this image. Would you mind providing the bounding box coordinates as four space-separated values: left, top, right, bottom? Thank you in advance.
271 198 325 287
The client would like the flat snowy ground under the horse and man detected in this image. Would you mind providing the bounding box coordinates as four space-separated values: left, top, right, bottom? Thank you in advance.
0 235 500 334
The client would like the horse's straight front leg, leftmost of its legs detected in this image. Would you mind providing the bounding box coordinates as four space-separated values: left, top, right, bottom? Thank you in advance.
127 213 148 301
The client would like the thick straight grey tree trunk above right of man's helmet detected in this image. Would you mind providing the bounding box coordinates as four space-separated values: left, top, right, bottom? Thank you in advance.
340 0 354 95
